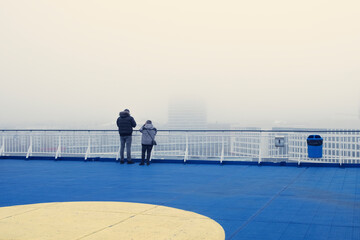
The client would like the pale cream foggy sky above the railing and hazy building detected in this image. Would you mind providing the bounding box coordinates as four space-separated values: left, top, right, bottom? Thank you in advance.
0 0 360 128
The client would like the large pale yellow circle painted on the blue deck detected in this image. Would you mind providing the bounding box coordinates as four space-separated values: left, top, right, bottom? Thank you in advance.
0 202 225 240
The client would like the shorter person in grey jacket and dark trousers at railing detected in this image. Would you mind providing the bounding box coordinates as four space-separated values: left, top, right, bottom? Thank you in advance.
139 120 157 165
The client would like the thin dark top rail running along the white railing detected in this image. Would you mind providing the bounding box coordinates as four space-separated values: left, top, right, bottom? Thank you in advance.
0 129 360 133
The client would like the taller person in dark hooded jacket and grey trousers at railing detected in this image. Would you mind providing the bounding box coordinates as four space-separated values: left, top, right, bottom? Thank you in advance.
116 109 136 164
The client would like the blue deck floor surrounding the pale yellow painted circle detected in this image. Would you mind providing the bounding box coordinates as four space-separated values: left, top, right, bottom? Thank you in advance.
0 159 360 240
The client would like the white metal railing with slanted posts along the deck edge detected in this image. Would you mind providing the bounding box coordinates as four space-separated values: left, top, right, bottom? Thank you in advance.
0 129 360 165
